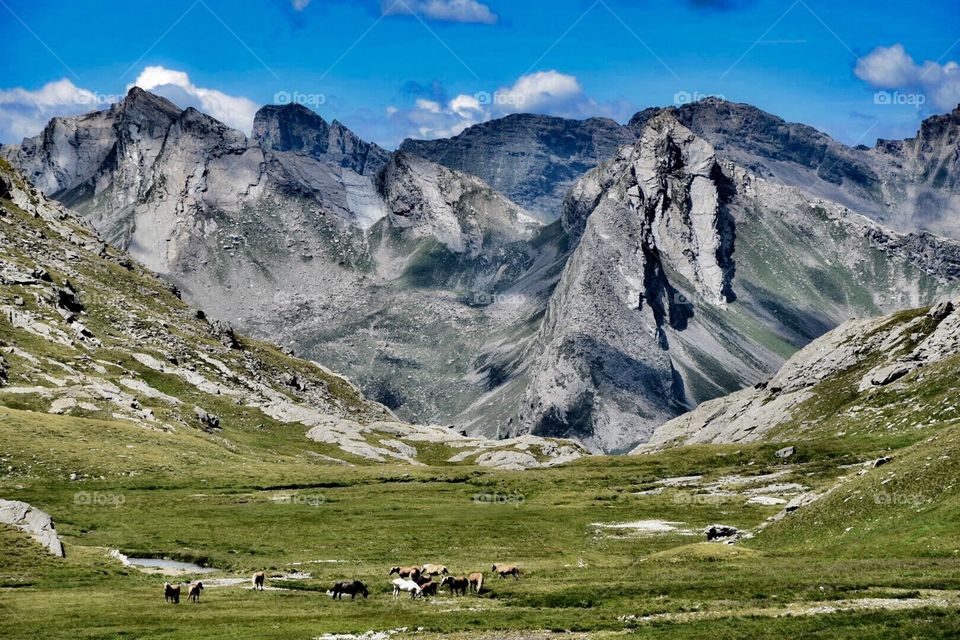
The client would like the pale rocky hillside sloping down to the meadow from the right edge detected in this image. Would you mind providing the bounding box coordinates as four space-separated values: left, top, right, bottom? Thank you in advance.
637 302 960 452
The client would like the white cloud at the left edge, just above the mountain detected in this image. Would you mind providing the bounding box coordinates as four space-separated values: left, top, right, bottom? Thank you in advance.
0 78 109 143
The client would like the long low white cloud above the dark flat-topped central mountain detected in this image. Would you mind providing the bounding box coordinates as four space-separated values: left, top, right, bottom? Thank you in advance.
387 70 632 144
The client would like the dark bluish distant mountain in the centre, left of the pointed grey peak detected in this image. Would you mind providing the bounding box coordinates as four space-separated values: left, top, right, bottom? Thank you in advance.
400 114 636 222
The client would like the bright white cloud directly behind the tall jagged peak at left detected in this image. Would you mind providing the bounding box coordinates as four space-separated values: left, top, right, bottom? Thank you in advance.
128 66 257 134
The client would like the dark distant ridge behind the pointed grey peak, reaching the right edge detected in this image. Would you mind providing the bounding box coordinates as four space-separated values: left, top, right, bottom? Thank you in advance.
628 99 960 239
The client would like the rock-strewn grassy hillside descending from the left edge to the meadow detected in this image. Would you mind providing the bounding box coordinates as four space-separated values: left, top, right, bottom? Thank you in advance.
0 161 582 475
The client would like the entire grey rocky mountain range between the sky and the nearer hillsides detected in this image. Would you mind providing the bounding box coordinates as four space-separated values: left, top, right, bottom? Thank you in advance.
0 88 960 452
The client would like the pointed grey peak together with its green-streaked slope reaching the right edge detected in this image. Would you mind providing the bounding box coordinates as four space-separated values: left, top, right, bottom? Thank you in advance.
515 112 960 451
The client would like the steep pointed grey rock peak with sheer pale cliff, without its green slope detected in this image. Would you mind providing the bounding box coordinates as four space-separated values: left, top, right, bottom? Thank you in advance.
521 114 733 450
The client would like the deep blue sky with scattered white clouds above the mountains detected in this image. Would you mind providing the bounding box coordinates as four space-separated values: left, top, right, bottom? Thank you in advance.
0 0 960 147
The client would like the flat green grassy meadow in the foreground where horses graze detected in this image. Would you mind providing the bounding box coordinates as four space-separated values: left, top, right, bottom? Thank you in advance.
0 416 960 639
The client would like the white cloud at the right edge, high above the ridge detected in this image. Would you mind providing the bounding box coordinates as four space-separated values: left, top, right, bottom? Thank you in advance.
854 43 960 111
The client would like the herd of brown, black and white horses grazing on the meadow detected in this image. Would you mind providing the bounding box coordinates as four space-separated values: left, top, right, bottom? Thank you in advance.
163 564 520 604
